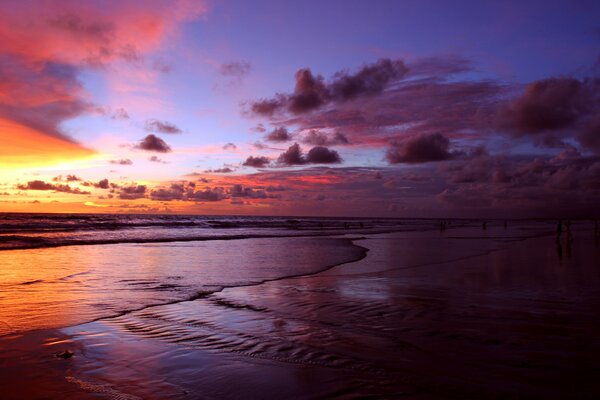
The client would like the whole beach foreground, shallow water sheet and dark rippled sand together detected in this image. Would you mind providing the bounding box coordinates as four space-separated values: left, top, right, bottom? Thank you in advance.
0 221 600 399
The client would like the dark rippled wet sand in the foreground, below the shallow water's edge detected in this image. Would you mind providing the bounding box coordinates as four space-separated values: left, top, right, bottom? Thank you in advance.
0 227 600 399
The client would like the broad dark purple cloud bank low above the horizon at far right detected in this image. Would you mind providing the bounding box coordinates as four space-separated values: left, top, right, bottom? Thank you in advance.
438 153 600 216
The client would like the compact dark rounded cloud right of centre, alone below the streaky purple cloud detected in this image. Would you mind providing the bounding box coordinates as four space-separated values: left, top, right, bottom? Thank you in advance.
385 133 453 164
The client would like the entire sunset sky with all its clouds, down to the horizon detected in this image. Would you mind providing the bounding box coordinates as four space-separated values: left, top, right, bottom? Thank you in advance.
0 0 600 218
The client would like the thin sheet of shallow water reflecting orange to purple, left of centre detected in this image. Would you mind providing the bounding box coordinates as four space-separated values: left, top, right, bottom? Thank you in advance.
0 237 364 335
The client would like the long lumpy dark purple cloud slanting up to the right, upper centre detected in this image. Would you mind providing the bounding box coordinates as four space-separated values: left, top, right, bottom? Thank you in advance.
250 59 408 116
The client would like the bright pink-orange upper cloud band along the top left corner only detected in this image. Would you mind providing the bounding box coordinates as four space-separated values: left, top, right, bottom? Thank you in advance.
0 0 206 64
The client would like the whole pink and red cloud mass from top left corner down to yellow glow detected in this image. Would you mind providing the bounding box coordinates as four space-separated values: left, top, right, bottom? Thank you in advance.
0 0 206 151
